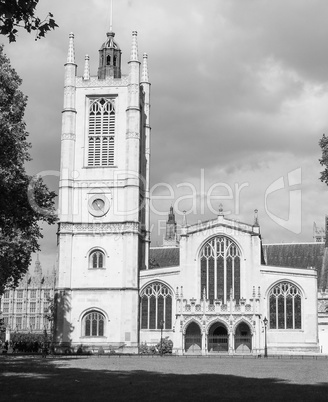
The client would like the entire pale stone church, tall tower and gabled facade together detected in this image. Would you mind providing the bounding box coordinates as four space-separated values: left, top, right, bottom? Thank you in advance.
56 27 328 354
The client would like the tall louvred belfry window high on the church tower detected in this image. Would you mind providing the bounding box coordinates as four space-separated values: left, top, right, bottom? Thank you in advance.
88 98 115 166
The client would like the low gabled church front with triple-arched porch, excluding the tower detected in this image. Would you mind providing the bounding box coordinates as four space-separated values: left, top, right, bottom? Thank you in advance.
140 211 327 355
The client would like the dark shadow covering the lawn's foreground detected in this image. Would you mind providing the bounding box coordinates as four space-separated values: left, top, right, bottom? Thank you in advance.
0 357 328 402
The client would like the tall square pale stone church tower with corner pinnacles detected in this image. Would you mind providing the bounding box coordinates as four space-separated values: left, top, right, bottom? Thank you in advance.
56 30 150 352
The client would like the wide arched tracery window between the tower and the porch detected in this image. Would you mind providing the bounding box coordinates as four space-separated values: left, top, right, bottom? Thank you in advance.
140 282 172 329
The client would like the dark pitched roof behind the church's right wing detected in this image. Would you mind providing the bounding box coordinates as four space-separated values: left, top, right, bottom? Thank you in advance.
263 243 328 289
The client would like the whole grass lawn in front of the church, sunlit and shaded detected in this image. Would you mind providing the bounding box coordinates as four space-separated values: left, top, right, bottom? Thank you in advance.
0 356 328 402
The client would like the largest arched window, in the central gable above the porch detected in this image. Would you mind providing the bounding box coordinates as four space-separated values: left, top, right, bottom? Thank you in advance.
200 236 240 303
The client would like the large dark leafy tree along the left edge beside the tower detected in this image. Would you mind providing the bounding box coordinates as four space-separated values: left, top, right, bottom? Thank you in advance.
0 46 57 294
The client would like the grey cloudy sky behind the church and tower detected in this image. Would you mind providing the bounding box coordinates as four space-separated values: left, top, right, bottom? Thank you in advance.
2 0 328 268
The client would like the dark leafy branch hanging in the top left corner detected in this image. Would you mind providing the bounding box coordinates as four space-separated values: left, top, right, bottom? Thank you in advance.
0 0 58 42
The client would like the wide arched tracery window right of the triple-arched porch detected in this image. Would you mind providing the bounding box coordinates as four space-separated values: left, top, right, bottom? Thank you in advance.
269 282 302 329
